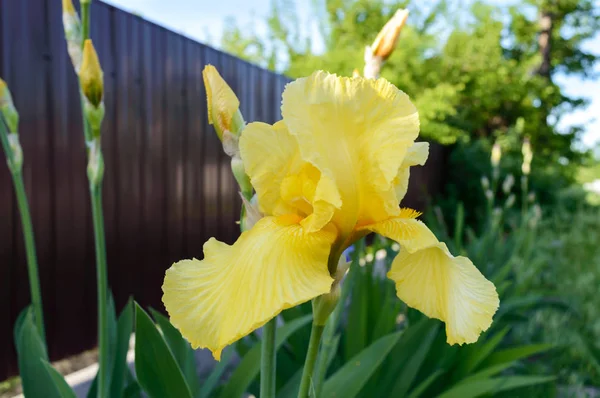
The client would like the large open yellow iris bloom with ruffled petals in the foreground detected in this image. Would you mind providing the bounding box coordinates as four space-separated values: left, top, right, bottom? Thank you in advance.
163 71 499 359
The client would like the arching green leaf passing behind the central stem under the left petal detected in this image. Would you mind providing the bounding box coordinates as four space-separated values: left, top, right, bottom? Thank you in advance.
221 314 312 398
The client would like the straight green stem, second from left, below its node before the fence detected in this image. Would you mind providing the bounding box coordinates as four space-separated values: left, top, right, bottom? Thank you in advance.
90 185 110 398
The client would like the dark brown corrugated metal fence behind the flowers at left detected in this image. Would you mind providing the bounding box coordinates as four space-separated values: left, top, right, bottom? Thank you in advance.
0 0 442 380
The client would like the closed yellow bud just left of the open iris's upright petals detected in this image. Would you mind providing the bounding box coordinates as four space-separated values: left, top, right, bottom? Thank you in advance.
202 65 245 143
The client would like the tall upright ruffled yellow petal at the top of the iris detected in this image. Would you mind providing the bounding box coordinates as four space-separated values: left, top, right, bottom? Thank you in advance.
281 72 419 234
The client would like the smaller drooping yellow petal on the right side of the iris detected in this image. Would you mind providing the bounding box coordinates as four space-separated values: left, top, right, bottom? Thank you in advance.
388 243 499 344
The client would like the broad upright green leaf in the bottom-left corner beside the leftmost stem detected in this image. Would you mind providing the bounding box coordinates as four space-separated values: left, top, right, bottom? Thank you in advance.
14 307 61 398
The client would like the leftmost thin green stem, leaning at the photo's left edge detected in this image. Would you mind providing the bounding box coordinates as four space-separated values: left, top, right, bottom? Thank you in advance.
0 117 46 346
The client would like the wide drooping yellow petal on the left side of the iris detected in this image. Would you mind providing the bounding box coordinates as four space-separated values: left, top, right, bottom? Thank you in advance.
163 215 335 360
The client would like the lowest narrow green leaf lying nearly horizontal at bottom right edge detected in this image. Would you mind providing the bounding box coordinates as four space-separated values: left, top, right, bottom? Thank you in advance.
438 376 554 398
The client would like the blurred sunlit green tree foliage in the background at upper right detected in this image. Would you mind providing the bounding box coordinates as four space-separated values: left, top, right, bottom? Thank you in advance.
220 0 600 222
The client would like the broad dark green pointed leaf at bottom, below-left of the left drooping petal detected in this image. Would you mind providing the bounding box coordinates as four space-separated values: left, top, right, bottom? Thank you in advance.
135 304 192 398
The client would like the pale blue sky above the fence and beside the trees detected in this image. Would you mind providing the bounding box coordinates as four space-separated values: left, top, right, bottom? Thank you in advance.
104 0 600 147
